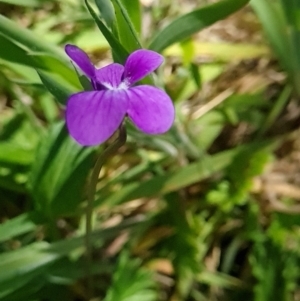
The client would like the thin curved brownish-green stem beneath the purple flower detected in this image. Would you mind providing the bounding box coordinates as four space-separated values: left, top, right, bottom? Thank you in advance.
85 124 127 300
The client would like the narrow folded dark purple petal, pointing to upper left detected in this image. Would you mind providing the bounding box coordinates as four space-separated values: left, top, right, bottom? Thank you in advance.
65 44 95 78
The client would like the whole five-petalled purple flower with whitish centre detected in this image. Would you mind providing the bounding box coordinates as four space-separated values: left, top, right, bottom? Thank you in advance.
65 45 175 145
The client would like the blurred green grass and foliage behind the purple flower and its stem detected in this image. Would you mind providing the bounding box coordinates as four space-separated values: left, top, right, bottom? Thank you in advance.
0 0 300 301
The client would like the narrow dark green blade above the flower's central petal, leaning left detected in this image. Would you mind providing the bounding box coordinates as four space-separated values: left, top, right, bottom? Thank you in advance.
84 0 129 64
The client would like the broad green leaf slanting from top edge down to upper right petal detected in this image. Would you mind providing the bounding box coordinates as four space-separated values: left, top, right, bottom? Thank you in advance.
149 0 249 52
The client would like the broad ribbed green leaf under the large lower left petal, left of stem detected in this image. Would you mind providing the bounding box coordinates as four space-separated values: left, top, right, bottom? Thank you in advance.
29 123 93 219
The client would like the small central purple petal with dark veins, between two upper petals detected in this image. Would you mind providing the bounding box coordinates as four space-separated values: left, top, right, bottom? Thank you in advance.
96 63 124 89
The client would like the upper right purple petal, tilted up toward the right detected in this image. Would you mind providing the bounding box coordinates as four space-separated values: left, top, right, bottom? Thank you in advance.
124 49 164 85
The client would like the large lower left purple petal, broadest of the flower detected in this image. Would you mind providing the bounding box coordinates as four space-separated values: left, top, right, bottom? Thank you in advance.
66 90 128 146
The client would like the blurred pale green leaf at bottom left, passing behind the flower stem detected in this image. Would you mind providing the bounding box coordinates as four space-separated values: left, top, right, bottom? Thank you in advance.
0 220 145 300
